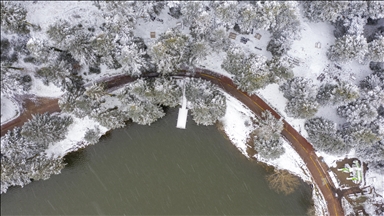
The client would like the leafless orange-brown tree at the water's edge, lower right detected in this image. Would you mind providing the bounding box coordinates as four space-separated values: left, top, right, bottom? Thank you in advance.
266 170 300 195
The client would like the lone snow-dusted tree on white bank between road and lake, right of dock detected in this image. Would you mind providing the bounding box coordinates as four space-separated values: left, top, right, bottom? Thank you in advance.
252 110 285 160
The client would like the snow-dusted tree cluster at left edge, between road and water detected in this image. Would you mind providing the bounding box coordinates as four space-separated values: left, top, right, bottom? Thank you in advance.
1 113 72 193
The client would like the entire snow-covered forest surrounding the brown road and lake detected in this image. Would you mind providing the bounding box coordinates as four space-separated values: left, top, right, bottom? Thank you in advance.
0 1 384 213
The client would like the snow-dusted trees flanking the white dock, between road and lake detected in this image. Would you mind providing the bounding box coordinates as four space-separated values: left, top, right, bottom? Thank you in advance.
59 77 226 129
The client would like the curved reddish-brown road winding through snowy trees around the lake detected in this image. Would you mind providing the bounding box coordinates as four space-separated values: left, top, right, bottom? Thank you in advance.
1 68 344 216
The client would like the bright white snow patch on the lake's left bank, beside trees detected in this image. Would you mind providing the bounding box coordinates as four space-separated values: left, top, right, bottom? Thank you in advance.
46 115 108 157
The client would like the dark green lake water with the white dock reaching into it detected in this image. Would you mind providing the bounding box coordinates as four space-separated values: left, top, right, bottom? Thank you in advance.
1 109 311 215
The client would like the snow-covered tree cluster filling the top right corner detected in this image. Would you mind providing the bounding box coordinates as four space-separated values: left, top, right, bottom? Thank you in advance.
303 1 384 63
